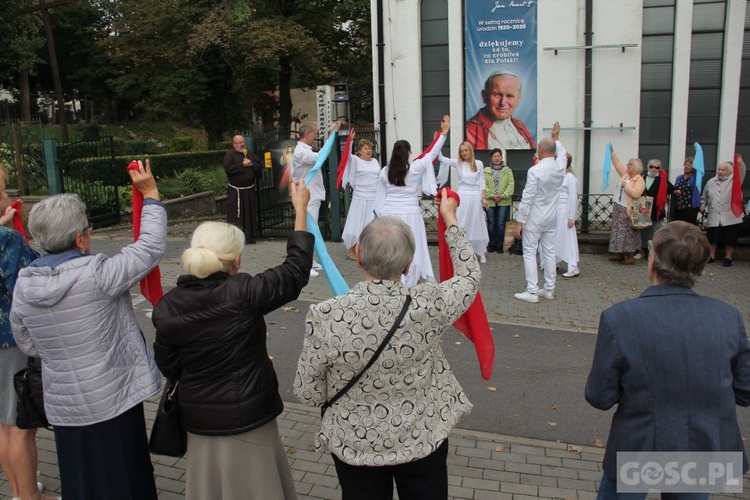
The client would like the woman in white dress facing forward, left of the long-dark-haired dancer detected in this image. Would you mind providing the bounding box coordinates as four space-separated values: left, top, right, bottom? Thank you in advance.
342 137 381 260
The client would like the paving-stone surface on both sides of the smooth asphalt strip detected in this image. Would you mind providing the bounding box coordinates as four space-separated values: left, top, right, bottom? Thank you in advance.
0 224 750 500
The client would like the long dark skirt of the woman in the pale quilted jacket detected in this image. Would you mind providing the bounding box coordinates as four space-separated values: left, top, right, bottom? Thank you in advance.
55 403 157 500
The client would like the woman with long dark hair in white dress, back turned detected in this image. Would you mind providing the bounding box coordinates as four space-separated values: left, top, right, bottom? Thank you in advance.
375 115 451 287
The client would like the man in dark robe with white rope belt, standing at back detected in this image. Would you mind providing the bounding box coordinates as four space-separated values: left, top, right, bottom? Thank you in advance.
224 135 263 243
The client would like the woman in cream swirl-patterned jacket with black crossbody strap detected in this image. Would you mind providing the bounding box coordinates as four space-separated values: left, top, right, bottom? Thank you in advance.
294 192 480 500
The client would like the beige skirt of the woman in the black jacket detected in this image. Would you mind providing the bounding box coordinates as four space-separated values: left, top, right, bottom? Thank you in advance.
185 419 297 500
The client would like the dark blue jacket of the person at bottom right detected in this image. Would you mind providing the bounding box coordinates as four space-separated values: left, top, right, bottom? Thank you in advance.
586 285 750 479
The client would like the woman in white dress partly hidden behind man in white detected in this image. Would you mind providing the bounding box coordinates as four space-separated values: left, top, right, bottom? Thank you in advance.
555 153 580 278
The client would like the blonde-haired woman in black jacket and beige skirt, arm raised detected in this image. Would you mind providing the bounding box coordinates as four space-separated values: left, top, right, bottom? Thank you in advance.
153 181 314 500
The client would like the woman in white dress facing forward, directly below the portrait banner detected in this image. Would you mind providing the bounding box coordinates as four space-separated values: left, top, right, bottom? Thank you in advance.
438 141 490 264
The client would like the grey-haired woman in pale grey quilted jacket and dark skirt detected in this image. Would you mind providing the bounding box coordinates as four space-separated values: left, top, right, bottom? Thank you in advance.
11 160 167 500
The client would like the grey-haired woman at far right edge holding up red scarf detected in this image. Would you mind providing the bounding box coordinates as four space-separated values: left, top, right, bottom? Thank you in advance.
700 158 745 267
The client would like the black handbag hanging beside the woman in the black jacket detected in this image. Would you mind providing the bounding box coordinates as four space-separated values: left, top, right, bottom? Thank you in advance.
148 380 187 458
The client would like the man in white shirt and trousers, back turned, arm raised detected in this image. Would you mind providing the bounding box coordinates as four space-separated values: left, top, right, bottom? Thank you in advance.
514 122 567 302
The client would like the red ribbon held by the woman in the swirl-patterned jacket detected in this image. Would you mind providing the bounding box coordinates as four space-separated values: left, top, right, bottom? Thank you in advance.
435 188 495 380
